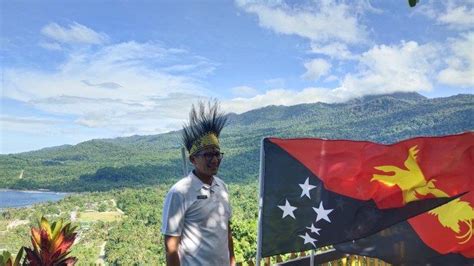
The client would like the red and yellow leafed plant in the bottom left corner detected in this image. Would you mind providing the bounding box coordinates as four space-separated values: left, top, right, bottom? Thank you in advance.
25 217 77 265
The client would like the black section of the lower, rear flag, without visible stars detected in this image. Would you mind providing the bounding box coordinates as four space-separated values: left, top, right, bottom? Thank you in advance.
334 221 474 266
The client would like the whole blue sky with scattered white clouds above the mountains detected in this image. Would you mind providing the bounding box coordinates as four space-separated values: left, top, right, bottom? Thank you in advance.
0 0 474 154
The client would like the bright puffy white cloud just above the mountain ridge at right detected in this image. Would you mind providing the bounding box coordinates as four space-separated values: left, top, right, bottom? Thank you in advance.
336 42 439 97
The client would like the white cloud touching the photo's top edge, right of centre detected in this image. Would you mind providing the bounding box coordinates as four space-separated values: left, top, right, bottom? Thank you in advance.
237 0 367 44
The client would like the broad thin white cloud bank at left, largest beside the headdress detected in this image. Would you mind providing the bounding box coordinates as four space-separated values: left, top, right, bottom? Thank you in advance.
2 42 215 135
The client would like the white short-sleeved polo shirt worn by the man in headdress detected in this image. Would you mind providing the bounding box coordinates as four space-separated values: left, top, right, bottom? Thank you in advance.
161 172 232 266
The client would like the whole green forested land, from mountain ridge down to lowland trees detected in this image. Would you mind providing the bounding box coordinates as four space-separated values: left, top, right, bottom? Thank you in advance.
0 94 474 265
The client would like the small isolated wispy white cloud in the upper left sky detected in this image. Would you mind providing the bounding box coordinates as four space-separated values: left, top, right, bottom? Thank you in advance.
41 22 108 44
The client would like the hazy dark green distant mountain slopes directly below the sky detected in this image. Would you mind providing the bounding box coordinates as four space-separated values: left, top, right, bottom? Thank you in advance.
0 93 474 191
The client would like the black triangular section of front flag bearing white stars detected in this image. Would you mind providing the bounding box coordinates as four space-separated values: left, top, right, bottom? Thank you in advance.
261 139 458 257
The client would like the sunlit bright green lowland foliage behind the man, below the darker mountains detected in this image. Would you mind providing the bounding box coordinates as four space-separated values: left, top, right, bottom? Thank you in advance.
0 182 258 265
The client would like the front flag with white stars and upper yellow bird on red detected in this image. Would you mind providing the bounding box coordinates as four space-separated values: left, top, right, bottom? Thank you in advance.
260 133 473 257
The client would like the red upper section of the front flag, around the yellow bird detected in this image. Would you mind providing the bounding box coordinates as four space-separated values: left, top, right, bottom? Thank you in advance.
270 132 474 208
